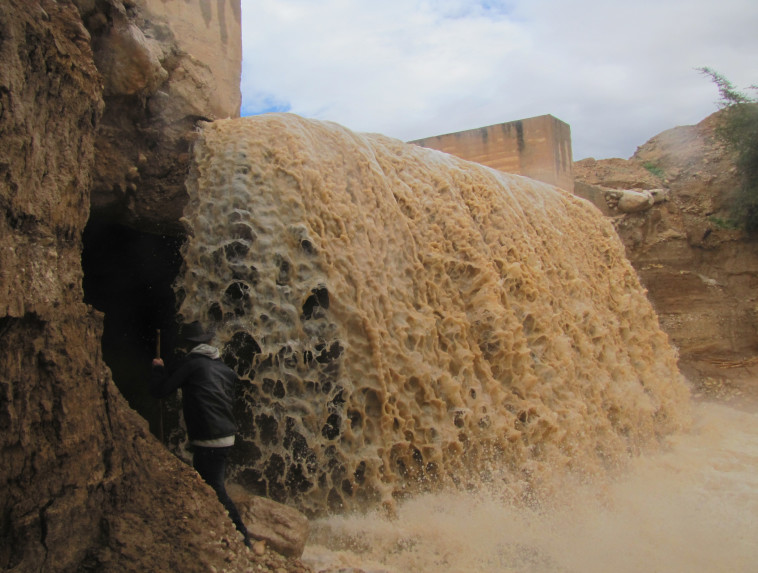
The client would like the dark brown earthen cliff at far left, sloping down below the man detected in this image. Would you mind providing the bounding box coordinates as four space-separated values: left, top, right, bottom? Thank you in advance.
0 0 303 572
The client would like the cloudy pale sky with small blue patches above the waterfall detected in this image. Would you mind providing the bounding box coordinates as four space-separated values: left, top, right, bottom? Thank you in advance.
241 0 758 160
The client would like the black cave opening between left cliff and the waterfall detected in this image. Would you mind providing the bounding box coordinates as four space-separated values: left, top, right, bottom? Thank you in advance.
82 217 184 440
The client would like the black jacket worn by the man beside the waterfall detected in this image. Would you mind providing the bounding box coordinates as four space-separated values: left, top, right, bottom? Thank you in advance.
150 353 238 441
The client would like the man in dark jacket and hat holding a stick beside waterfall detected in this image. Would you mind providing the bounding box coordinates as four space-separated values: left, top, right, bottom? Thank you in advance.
150 322 250 547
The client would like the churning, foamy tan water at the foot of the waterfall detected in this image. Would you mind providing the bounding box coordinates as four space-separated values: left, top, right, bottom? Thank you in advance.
304 404 758 573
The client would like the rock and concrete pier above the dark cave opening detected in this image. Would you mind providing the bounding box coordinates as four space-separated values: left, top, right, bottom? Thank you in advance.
76 0 241 232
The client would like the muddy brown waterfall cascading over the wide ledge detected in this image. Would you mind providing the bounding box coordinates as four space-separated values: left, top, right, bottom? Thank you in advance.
176 114 690 515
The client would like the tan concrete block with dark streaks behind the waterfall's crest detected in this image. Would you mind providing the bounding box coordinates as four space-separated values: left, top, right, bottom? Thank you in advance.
410 115 574 192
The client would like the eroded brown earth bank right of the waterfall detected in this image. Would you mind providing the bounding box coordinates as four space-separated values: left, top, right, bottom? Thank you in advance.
574 113 758 398
